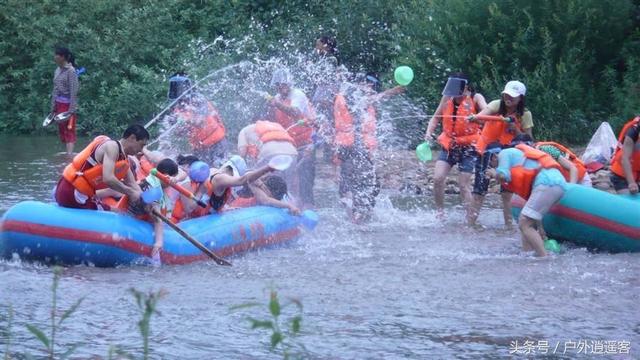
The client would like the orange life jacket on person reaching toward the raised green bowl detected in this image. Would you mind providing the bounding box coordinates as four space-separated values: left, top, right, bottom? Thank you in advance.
333 94 378 151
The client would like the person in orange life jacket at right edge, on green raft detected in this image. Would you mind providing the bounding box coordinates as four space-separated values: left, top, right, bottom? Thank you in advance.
611 116 640 194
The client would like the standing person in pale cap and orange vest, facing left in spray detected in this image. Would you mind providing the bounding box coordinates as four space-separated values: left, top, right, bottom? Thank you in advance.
269 68 316 207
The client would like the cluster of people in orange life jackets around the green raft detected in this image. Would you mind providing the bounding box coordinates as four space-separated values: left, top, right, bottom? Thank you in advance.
425 73 640 256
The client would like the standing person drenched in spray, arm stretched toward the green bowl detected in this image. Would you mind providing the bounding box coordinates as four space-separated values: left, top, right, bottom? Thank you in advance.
333 73 404 223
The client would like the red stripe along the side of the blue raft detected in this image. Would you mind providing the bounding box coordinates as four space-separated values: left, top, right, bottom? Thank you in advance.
2 220 300 265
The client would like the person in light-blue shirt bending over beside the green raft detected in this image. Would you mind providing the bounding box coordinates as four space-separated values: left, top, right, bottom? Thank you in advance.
485 143 567 256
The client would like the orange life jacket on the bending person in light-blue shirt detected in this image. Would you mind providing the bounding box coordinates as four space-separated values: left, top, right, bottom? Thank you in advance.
502 144 561 199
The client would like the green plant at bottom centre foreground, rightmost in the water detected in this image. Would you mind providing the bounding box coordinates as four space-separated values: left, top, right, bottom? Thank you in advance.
230 290 306 359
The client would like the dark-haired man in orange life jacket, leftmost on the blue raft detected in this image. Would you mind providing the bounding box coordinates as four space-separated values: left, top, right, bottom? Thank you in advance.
55 125 149 210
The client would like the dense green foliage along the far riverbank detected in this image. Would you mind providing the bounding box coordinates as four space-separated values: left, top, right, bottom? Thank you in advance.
0 0 640 143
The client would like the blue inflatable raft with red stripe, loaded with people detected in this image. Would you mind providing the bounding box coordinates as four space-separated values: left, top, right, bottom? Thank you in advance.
0 201 317 267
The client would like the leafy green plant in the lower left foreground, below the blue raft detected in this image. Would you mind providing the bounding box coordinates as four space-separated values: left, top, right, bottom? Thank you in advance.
27 266 84 360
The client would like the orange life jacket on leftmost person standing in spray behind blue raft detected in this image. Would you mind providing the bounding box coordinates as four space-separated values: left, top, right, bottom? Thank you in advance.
176 101 225 149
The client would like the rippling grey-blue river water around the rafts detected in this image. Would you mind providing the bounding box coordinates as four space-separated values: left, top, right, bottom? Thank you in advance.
0 137 640 359
